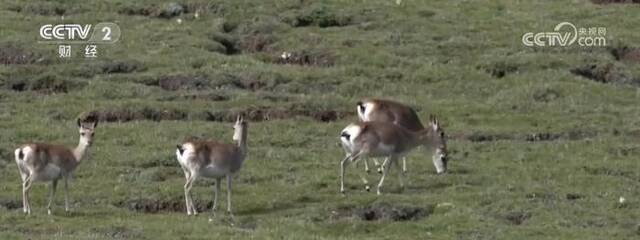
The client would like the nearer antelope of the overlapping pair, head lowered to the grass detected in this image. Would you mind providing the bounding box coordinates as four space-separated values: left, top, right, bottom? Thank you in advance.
340 116 447 195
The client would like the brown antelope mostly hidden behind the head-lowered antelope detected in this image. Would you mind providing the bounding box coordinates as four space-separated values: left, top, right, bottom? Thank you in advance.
356 99 447 173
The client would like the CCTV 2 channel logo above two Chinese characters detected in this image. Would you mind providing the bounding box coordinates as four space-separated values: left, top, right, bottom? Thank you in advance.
40 23 120 44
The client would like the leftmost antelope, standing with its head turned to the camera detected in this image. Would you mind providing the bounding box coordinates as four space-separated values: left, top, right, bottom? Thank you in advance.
15 119 98 215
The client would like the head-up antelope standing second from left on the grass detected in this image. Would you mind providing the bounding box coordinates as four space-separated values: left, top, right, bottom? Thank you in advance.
176 115 248 217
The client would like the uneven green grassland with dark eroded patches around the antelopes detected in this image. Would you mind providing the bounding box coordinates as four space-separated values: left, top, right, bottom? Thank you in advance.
0 0 640 240
